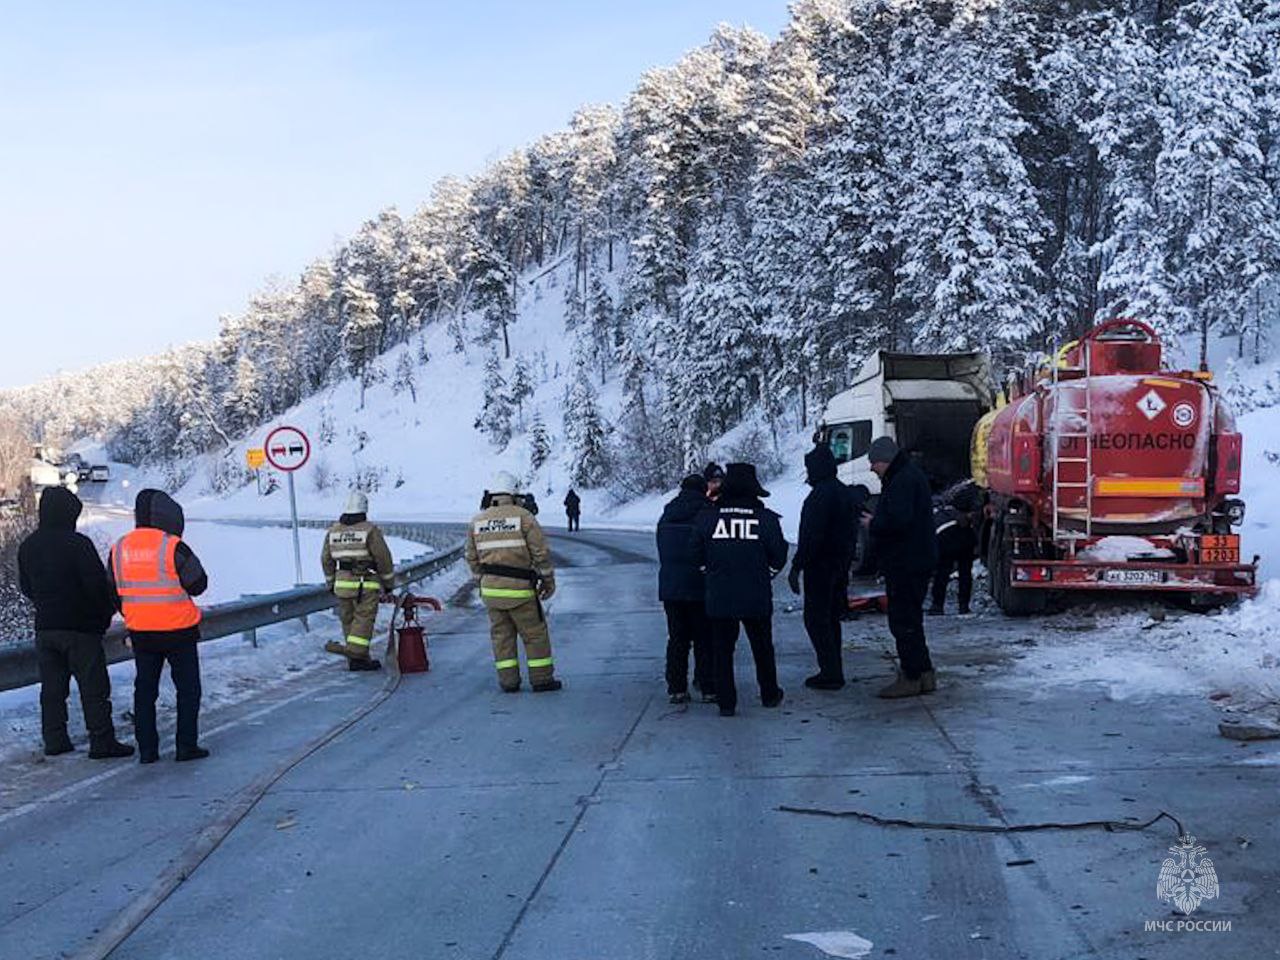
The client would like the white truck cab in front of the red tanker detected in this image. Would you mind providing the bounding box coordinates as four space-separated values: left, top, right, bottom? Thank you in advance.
817 351 996 494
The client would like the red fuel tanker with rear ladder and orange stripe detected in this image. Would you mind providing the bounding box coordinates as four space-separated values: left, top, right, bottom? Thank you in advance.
973 320 1257 614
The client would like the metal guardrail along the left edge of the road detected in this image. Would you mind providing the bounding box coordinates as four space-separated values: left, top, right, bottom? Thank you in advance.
0 521 462 690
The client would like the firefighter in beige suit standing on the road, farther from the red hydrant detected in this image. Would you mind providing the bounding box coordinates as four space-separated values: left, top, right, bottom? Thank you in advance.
467 472 561 694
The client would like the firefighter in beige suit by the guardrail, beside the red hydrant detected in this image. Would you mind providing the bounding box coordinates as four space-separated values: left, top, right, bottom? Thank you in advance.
320 490 396 671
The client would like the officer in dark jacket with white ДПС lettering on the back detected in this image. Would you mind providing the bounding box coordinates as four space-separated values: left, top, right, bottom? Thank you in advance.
692 463 787 717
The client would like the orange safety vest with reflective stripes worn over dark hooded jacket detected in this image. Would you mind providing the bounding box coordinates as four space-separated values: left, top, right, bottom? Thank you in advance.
111 527 200 632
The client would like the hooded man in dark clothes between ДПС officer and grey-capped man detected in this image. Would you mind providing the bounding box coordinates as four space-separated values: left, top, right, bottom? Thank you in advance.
787 443 855 690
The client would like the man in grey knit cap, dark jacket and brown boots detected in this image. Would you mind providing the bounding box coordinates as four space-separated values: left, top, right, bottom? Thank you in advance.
868 436 938 699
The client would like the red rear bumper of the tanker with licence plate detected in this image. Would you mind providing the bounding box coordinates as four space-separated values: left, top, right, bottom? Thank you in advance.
1011 559 1258 596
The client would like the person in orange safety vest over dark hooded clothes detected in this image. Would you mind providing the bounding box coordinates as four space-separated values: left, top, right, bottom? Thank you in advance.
108 489 209 763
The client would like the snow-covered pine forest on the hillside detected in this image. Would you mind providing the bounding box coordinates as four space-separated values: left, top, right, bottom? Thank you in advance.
4 0 1280 492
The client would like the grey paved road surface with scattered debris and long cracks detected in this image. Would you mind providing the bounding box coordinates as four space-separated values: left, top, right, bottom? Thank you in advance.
0 531 1280 960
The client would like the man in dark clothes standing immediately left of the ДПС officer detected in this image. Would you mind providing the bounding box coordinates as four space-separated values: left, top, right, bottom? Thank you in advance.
658 474 716 703
